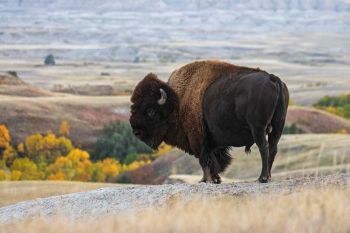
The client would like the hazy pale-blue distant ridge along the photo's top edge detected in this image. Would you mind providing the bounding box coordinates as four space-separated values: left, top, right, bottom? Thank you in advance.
0 0 350 11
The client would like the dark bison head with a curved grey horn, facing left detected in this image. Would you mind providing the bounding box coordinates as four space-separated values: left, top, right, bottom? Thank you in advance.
130 73 177 149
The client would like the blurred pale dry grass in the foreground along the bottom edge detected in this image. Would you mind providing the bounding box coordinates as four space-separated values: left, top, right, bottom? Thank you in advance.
0 187 350 233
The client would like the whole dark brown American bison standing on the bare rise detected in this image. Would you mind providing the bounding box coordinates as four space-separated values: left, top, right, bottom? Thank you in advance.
130 61 289 183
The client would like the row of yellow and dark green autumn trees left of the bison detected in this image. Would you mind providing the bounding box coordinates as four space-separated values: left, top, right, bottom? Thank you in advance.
0 121 171 182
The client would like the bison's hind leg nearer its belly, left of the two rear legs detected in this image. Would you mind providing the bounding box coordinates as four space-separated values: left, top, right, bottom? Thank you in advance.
253 126 270 183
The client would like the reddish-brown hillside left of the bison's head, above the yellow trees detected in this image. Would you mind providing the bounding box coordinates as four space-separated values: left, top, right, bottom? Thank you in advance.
0 94 129 149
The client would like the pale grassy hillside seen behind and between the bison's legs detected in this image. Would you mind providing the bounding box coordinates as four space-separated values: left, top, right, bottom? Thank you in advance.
123 134 350 184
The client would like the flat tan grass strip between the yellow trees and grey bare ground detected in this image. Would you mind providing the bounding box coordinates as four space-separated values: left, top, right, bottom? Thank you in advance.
0 181 116 207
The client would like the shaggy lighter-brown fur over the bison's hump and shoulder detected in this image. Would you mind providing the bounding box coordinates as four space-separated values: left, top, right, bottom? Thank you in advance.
165 61 260 157
